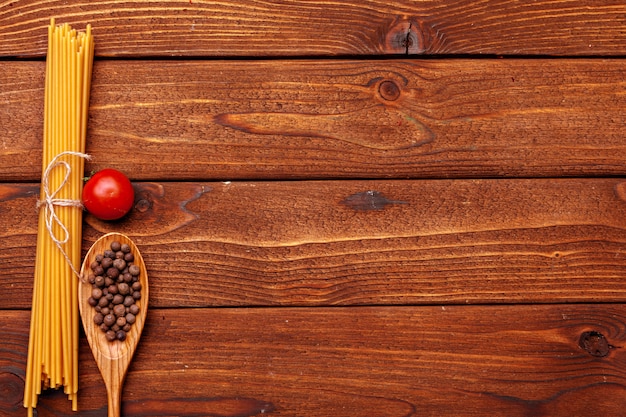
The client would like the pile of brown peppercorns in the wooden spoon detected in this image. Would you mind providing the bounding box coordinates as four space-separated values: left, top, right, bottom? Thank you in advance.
88 241 141 342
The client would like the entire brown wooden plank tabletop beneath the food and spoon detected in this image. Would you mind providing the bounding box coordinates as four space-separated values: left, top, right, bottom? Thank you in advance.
0 0 626 417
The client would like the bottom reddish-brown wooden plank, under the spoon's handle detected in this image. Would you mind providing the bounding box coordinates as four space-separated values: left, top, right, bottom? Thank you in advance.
0 304 626 417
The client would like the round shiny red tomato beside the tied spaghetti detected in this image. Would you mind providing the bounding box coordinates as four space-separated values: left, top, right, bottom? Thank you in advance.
83 168 135 220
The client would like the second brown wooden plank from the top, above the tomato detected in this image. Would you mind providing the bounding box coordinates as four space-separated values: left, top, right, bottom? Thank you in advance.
0 59 626 182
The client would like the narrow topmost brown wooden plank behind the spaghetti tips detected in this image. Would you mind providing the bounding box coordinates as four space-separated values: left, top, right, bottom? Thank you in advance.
0 0 626 57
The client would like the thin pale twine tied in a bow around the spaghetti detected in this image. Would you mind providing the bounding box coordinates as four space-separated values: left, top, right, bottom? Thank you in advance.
37 151 91 278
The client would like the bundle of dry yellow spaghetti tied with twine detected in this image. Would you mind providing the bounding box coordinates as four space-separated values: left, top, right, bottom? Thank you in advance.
24 19 94 416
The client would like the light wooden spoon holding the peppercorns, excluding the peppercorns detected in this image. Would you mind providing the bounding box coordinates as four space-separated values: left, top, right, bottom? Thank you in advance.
78 233 148 417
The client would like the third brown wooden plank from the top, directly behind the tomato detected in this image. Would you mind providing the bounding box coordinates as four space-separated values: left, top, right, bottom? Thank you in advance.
0 179 626 308
